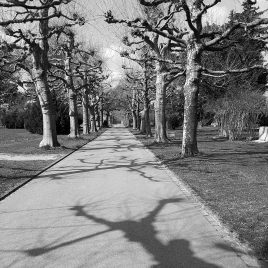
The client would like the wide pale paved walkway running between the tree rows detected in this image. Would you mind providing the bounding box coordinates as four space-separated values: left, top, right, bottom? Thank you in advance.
0 129 262 268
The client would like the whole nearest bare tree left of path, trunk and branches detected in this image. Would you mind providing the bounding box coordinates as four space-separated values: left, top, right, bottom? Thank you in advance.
0 0 84 147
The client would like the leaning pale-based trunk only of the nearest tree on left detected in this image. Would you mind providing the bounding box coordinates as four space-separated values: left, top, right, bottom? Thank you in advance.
31 9 59 147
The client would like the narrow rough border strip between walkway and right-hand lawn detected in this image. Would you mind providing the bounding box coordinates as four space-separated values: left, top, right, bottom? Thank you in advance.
128 129 268 268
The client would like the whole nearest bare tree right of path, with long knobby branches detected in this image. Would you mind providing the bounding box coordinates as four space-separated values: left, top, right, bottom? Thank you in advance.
106 0 268 157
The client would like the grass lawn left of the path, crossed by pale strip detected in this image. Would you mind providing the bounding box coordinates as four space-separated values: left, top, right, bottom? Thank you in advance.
0 128 103 198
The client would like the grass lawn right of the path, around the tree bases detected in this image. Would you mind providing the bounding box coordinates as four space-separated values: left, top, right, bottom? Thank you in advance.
134 127 268 260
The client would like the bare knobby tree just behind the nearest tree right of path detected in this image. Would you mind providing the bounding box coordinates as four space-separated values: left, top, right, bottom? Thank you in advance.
106 5 185 143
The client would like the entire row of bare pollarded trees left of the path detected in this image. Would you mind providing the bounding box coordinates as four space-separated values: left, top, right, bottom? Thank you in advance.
0 0 110 147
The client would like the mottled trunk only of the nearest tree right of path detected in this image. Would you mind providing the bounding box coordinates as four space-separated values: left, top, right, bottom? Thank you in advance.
182 41 201 157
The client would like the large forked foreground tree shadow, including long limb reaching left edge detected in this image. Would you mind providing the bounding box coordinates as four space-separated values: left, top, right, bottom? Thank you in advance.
2 198 251 268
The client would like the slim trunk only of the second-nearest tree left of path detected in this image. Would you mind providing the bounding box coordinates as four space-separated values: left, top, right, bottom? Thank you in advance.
65 32 79 138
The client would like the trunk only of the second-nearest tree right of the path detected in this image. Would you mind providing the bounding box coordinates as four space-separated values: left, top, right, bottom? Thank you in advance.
154 62 168 143
